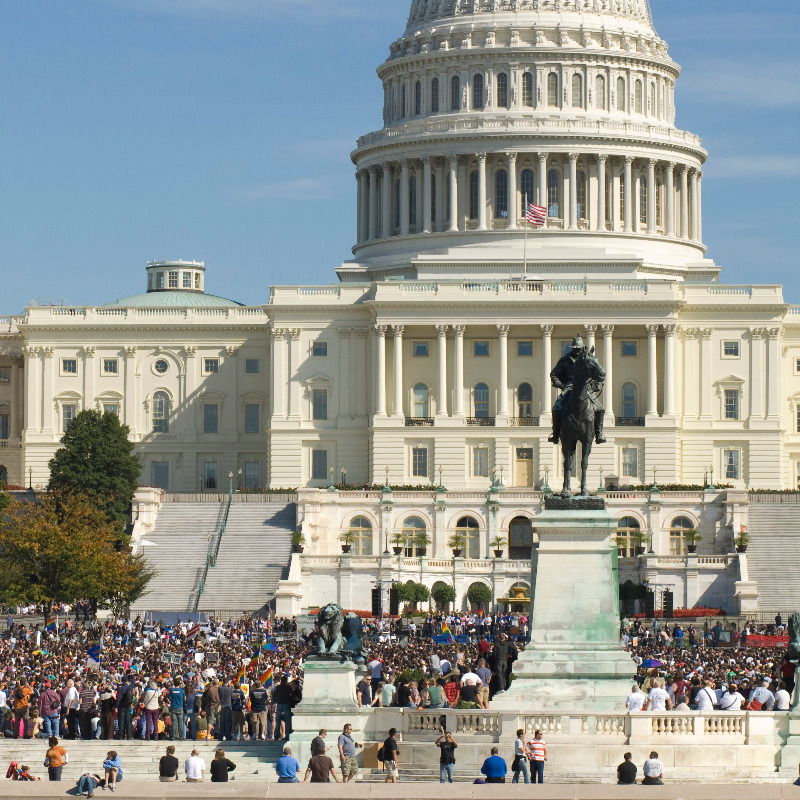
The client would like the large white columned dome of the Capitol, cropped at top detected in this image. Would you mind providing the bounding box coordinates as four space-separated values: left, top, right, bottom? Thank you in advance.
338 0 719 281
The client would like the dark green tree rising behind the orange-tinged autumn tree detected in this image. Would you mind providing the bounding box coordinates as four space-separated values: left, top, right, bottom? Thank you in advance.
48 409 142 538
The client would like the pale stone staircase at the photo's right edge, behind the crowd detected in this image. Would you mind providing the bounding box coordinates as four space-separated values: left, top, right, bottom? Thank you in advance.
747 495 800 621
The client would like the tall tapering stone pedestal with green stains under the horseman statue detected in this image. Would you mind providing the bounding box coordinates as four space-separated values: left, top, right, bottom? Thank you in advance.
492 506 636 713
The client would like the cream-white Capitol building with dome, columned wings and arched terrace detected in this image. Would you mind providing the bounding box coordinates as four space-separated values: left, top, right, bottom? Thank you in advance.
0 0 800 612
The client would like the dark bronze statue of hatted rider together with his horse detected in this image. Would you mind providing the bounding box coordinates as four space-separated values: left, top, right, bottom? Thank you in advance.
549 336 606 497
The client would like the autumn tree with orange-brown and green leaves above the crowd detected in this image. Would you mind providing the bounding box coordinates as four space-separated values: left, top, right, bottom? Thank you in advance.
0 493 152 615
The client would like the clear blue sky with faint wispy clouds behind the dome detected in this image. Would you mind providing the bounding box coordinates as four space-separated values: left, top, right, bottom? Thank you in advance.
0 0 800 314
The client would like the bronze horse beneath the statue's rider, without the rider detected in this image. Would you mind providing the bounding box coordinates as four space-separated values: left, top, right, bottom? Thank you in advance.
559 347 606 497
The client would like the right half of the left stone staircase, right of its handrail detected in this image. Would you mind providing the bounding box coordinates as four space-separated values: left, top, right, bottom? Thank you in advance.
198 502 297 612
